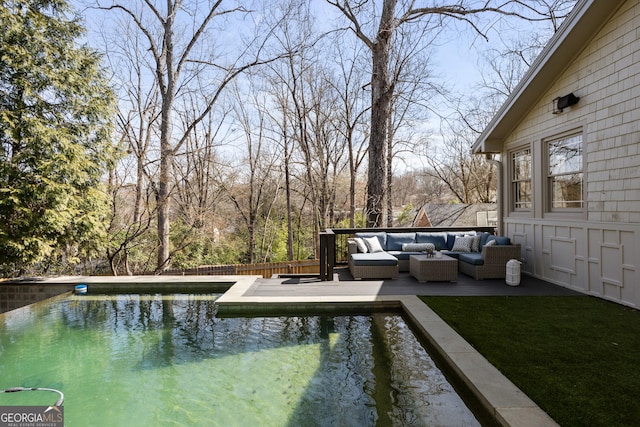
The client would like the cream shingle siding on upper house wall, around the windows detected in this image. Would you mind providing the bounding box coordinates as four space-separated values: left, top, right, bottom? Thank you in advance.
505 1 640 222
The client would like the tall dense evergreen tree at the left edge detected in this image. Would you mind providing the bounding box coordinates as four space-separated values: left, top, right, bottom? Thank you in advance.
0 0 116 273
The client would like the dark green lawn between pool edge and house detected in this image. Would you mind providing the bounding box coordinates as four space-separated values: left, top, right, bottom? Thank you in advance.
421 296 640 427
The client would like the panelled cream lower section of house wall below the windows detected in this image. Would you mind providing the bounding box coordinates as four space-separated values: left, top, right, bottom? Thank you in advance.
505 219 640 307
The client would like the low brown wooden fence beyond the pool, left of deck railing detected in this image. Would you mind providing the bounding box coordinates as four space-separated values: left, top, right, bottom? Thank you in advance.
162 259 320 278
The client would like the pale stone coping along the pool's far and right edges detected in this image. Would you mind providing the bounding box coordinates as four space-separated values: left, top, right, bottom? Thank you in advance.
7 276 558 427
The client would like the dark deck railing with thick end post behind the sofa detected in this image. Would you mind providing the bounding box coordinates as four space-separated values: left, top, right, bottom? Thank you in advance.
319 226 496 280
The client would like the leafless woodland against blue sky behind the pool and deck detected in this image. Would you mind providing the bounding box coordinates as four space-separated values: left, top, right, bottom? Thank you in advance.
75 0 575 274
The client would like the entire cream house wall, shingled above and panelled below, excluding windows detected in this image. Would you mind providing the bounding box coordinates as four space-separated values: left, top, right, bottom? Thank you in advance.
502 0 640 307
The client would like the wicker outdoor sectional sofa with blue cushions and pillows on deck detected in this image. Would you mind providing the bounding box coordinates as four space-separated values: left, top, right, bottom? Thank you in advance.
348 230 521 280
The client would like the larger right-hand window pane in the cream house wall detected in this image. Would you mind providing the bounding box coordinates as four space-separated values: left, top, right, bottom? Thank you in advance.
547 134 583 210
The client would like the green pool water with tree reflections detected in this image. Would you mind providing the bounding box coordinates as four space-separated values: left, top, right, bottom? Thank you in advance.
0 295 479 427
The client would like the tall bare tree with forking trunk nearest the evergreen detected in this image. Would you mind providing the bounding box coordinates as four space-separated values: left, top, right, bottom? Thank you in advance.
98 0 288 272
